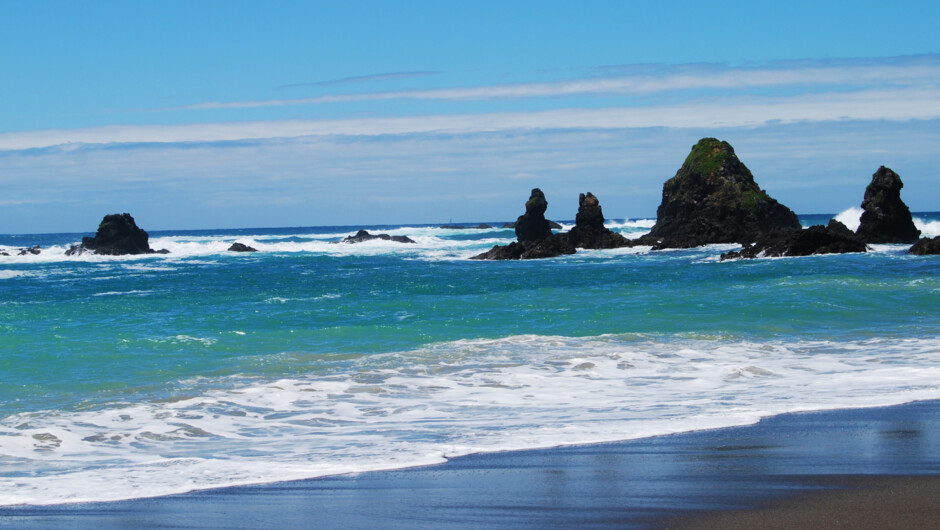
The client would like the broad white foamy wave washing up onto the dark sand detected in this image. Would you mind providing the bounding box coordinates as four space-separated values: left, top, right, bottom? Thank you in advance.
0 335 940 505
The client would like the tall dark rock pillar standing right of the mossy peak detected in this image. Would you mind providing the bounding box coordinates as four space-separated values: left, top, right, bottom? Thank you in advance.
855 166 920 243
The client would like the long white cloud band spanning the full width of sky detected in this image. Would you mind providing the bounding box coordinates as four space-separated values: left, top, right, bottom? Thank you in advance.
7 88 940 150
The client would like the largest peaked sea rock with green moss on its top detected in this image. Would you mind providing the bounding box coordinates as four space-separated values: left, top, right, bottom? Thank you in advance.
637 138 801 248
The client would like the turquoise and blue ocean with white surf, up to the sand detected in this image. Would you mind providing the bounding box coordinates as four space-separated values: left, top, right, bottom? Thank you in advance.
0 209 940 506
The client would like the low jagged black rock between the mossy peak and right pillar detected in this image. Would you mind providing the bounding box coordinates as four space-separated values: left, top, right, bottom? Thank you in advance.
721 219 866 261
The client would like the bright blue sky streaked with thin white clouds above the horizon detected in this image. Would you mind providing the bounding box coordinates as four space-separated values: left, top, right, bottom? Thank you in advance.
0 0 940 234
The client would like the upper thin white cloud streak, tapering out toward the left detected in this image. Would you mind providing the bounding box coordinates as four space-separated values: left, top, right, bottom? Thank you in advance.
180 55 940 109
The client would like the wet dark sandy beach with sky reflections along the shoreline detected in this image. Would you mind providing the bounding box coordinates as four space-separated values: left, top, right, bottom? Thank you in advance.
0 401 940 528
